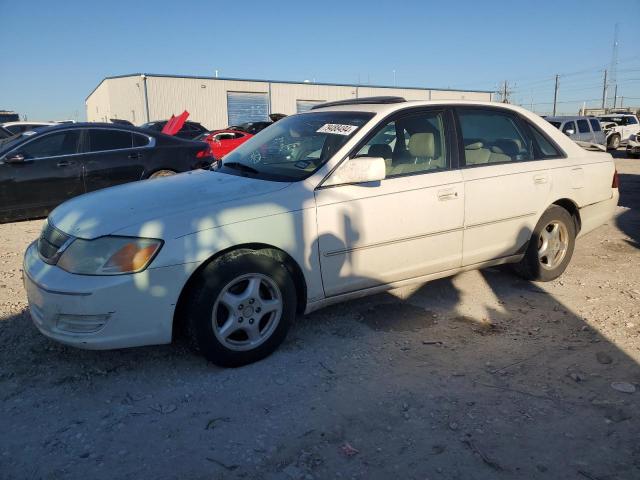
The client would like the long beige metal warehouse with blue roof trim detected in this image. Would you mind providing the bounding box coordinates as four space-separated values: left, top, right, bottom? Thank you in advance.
85 73 491 130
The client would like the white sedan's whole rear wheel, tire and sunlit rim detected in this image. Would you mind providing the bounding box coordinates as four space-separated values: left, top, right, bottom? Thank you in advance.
514 205 576 282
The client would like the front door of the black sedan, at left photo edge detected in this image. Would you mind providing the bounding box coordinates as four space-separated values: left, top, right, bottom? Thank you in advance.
0 129 85 218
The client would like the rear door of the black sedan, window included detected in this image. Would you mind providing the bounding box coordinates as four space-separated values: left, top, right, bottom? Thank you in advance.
84 128 148 192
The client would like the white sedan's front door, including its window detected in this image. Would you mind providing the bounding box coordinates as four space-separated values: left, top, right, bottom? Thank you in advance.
315 109 464 296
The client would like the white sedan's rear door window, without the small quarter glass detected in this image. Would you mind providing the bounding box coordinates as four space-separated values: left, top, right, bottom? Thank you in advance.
458 109 535 165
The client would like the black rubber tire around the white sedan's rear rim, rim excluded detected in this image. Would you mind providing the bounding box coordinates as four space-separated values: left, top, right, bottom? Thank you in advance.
514 205 576 282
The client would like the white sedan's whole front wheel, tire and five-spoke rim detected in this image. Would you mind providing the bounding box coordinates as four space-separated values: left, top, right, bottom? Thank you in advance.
188 250 296 367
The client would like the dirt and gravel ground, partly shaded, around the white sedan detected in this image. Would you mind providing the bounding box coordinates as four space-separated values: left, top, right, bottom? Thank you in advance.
0 159 640 480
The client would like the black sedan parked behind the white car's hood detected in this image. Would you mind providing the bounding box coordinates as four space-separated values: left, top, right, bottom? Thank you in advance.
0 123 212 223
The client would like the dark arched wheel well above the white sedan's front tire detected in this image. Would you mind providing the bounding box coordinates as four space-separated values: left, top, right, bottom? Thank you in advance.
173 243 307 338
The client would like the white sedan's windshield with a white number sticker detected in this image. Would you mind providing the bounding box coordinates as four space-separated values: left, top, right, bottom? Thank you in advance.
217 112 373 182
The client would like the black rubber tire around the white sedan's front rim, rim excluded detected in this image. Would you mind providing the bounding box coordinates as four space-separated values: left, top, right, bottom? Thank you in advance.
186 250 296 367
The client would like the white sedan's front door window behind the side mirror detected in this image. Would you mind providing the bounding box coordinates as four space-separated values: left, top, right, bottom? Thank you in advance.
355 112 449 178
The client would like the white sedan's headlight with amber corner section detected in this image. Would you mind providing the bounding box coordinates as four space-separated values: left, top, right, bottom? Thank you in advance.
58 236 163 275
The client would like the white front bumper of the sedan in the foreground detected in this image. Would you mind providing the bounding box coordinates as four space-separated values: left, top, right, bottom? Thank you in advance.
24 243 189 349
